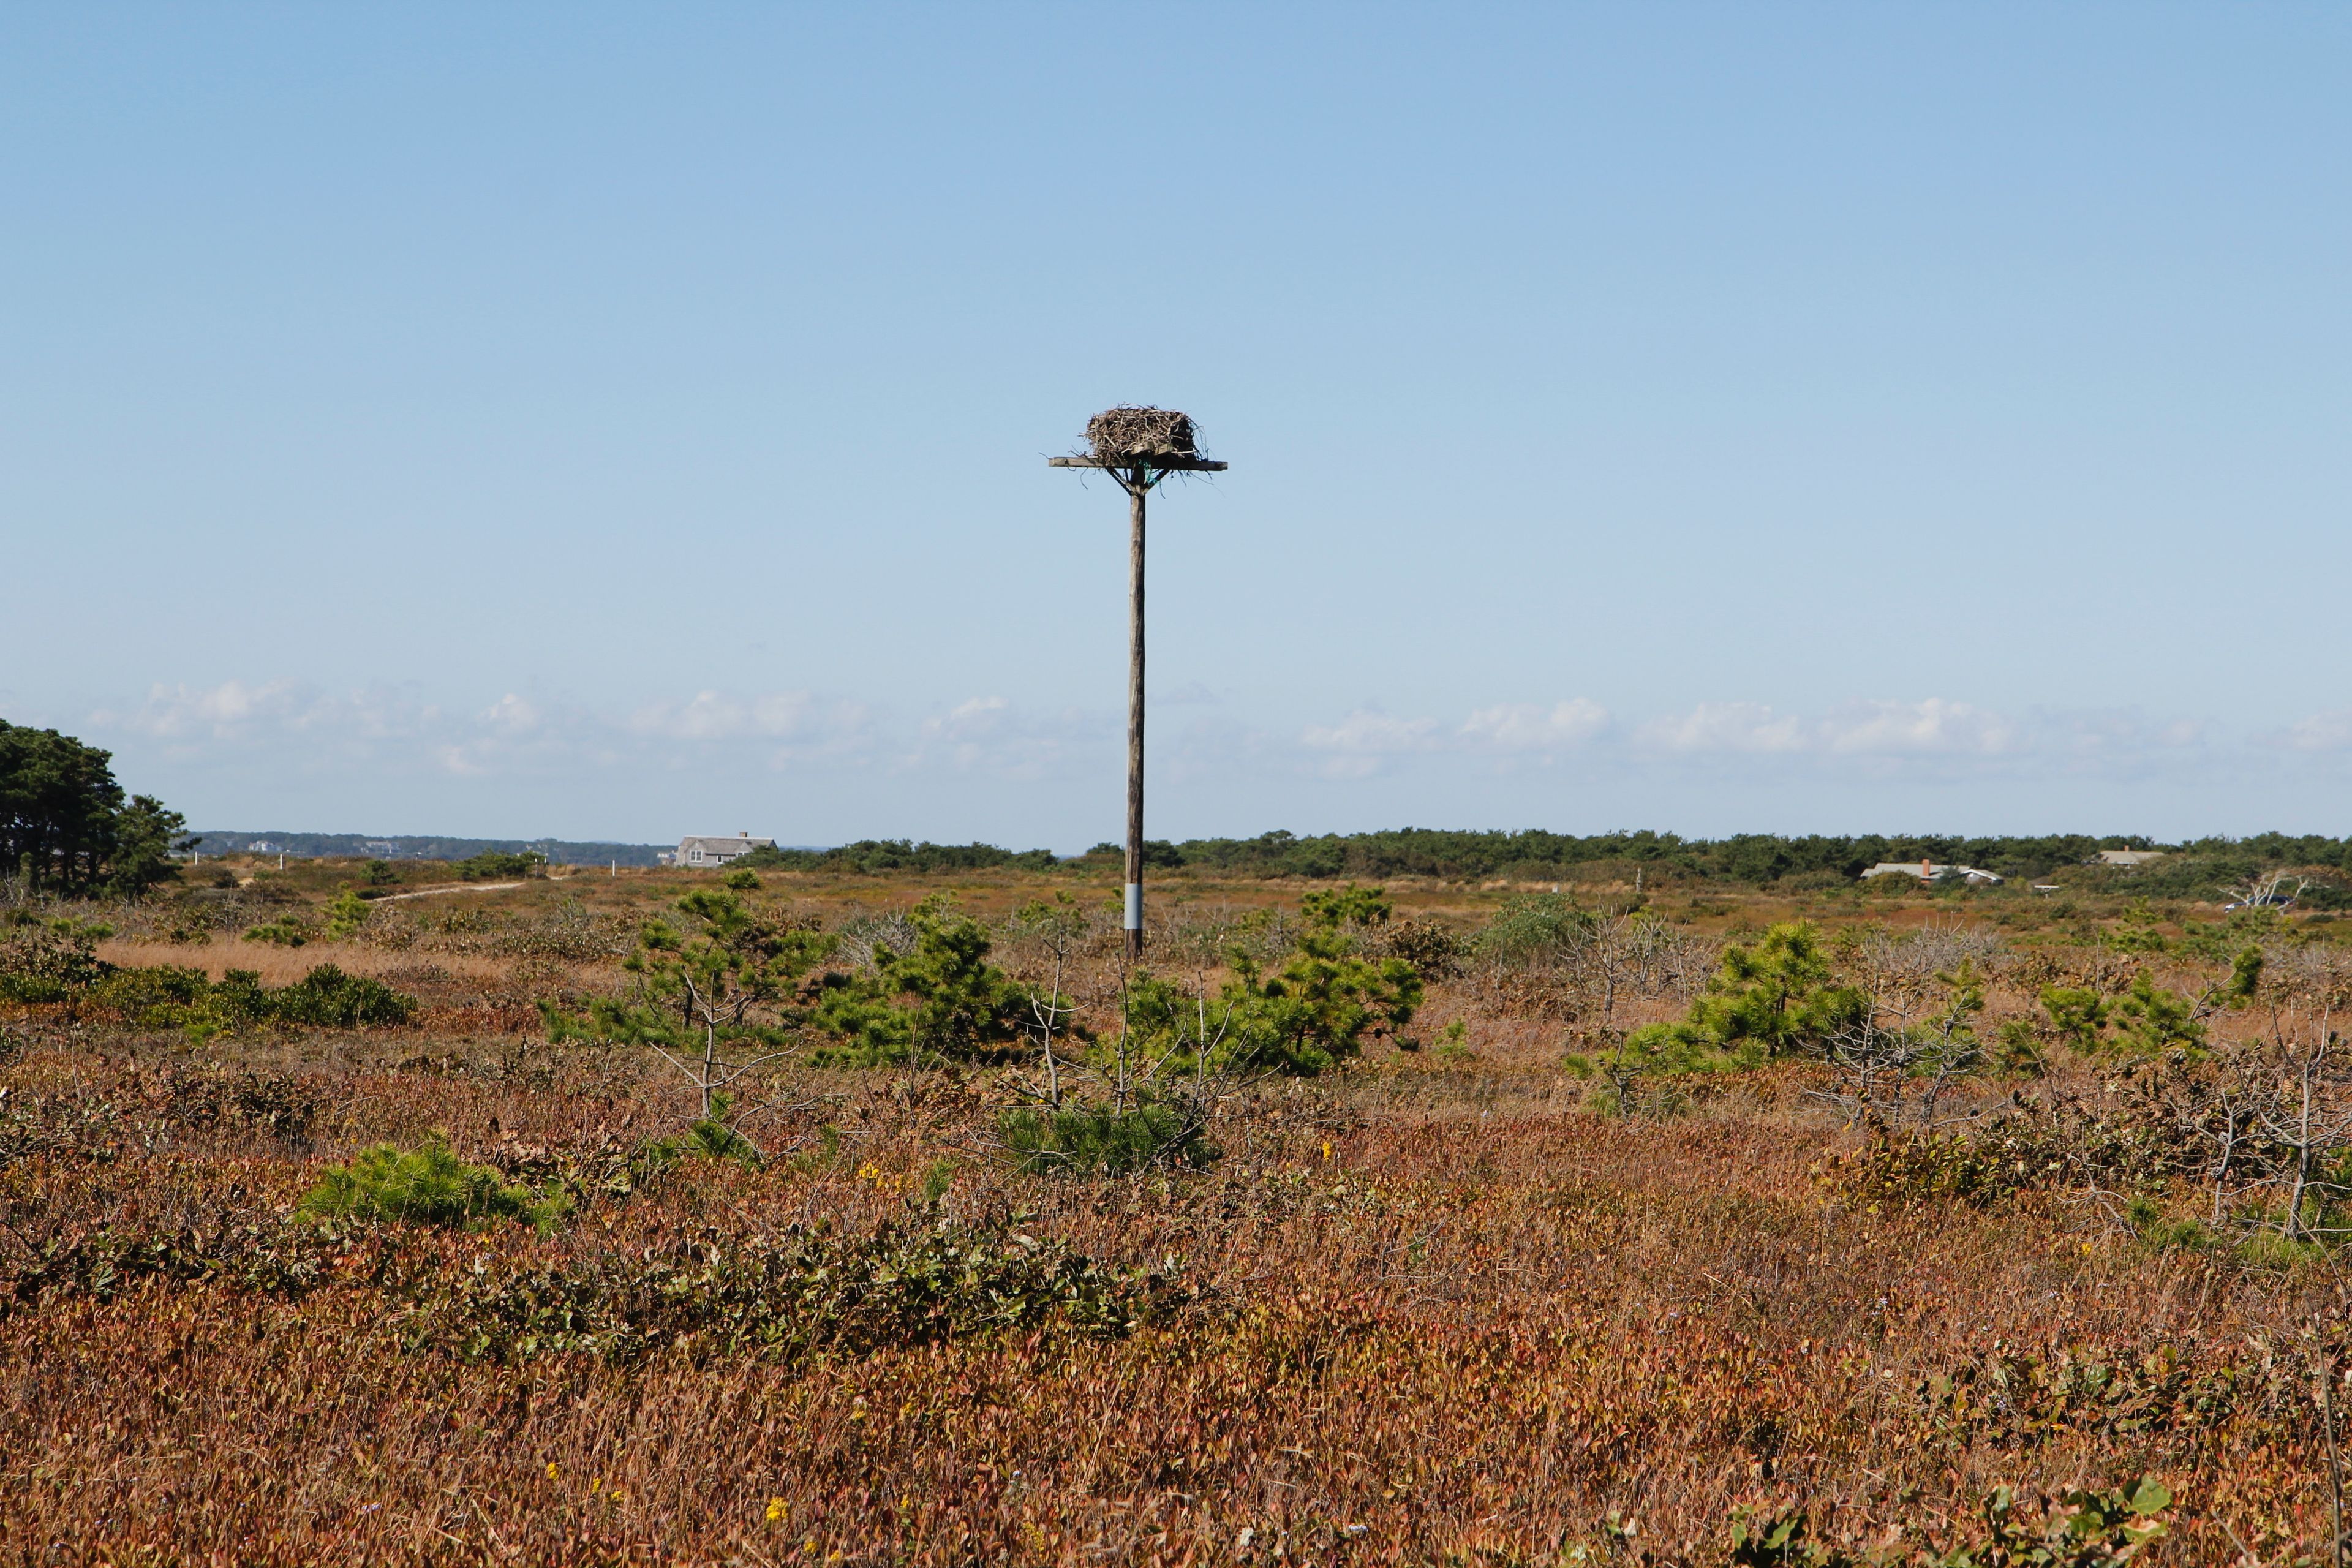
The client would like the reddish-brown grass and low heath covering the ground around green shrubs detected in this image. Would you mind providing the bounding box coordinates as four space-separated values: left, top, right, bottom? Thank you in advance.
0 865 2352 1563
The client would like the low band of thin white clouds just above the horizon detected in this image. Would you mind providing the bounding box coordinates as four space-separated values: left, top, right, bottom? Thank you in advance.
89 679 2258 799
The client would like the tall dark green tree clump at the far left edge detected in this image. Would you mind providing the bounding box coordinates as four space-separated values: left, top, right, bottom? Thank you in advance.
0 719 186 898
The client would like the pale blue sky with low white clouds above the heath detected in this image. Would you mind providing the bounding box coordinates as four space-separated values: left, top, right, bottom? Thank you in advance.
0 5 2352 849
